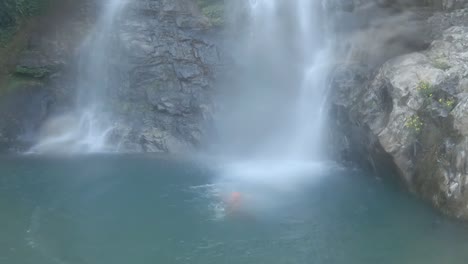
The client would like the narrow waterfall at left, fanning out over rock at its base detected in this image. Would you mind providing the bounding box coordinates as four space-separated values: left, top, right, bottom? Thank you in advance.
31 0 126 153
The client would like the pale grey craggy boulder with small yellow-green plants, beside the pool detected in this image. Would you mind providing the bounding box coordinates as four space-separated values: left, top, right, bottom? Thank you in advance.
333 7 468 219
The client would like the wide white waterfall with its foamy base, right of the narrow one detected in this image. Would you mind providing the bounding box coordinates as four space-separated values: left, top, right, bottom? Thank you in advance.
212 0 334 200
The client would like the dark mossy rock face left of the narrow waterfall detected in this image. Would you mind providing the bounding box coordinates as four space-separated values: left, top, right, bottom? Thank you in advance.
0 0 91 152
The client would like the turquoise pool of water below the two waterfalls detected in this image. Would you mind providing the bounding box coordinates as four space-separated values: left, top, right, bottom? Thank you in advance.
0 155 468 264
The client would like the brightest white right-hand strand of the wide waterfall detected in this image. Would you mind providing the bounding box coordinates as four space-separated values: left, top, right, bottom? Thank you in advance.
290 0 333 159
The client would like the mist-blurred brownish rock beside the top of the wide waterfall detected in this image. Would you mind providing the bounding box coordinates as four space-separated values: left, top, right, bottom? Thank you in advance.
329 0 433 67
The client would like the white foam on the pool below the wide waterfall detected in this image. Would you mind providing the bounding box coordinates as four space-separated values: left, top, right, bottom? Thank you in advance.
192 160 339 221
